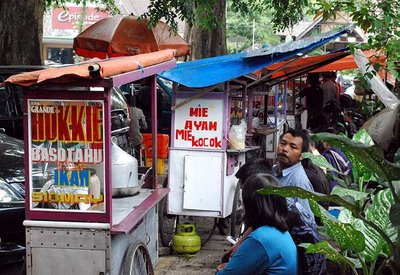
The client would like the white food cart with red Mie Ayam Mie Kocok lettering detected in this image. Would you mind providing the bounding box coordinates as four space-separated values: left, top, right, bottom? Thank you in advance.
155 74 259 246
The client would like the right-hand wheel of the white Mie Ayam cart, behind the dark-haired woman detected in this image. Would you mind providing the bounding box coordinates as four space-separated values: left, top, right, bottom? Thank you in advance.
231 181 244 239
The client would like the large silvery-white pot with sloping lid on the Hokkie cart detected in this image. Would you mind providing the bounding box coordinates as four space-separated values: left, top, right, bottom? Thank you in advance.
111 143 140 197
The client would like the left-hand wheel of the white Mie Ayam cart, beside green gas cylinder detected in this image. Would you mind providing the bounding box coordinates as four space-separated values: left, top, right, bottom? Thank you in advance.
158 178 178 247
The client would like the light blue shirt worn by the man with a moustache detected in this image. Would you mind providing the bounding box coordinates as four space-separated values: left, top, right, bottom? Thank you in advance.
273 162 314 219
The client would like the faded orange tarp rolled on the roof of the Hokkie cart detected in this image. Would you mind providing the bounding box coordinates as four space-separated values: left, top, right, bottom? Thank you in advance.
5 50 176 86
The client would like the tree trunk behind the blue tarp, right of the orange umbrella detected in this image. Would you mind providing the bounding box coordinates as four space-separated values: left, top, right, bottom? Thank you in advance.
185 0 227 60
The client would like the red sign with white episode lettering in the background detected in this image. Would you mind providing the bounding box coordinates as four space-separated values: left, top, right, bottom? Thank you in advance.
51 7 110 30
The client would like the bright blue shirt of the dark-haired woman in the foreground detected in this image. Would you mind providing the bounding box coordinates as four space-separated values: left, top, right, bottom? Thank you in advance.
217 225 297 275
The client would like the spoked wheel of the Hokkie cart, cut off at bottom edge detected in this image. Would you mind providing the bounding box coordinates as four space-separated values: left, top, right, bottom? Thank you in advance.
122 243 154 275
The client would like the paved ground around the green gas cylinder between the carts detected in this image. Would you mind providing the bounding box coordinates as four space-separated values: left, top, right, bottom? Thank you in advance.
155 218 229 275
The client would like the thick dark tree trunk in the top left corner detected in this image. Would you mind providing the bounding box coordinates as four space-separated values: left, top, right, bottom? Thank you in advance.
0 0 44 65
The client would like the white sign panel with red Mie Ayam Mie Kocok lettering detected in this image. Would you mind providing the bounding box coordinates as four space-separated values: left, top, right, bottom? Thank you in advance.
173 98 223 150
